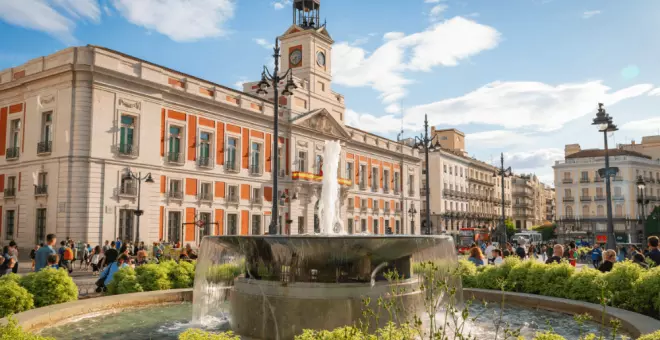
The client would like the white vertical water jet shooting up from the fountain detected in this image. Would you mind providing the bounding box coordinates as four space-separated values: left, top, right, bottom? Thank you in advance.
319 141 344 235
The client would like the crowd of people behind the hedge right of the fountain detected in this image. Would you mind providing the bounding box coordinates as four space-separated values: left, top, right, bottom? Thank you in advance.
468 236 660 272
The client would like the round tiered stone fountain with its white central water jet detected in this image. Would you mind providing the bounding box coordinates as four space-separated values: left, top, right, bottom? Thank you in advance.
188 141 460 339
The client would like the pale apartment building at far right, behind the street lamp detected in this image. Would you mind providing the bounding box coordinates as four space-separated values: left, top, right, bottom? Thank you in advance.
553 144 660 243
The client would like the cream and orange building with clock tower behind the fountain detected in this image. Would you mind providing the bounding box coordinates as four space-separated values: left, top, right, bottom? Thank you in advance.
0 2 421 245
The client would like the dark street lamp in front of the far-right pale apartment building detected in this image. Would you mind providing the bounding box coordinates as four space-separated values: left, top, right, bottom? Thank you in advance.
591 103 619 249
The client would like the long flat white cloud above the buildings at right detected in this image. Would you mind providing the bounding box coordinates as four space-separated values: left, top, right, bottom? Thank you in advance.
405 81 653 131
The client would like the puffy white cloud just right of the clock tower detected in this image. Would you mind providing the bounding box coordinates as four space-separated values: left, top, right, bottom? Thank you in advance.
333 17 500 103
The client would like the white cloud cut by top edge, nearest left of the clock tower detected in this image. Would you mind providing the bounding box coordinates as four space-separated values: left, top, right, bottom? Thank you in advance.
112 0 235 42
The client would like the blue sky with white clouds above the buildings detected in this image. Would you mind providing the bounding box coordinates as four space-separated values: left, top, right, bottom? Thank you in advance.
0 0 660 185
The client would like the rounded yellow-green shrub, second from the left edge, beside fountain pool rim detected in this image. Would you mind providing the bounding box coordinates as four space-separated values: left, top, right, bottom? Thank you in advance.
20 268 78 307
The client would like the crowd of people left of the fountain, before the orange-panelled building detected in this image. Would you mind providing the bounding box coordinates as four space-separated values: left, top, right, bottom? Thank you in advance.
0 234 197 291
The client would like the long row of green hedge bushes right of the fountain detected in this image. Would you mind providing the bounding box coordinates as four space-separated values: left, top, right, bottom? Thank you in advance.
458 257 660 320
